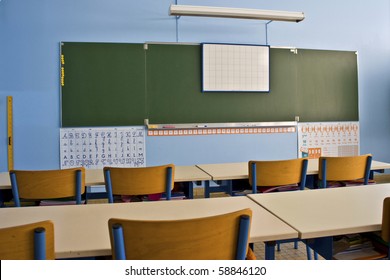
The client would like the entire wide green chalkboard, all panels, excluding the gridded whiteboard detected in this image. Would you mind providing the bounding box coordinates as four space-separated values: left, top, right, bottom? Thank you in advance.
62 43 358 127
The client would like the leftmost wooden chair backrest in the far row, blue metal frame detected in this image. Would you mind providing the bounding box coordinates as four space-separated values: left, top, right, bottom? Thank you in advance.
10 167 85 207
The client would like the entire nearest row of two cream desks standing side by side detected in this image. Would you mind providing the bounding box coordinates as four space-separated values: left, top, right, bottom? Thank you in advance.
0 184 390 259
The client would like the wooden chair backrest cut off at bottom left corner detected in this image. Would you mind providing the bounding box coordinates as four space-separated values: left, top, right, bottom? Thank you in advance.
0 221 55 260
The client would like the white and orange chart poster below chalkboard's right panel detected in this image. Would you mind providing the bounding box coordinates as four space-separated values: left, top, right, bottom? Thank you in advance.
298 122 359 158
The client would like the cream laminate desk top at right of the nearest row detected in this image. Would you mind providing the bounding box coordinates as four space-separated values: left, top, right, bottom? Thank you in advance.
248 184 390 239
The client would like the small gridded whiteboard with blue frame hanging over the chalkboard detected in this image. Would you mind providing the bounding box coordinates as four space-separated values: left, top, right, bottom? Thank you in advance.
202 44 269 92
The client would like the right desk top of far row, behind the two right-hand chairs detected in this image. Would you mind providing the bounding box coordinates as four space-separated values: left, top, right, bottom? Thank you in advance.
197 159 390 180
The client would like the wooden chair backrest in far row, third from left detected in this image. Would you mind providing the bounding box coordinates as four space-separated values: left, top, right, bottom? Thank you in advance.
248 158 308 193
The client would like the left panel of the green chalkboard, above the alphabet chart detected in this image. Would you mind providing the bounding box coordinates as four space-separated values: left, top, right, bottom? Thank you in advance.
61 43 146 127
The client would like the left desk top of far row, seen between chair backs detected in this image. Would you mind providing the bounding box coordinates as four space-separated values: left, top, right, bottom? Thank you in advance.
0 165 211 189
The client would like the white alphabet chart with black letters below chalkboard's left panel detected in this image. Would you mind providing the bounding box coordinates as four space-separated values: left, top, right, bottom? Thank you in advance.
60 126 146 169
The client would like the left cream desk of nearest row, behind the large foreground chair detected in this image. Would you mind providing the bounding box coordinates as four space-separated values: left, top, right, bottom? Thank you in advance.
0 197 298 259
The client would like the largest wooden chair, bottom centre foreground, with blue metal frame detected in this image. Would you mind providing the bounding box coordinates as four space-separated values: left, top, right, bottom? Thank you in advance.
108 209 252 260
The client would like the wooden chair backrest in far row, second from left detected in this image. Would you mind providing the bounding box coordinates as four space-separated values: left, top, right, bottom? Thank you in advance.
104 164 175 203
